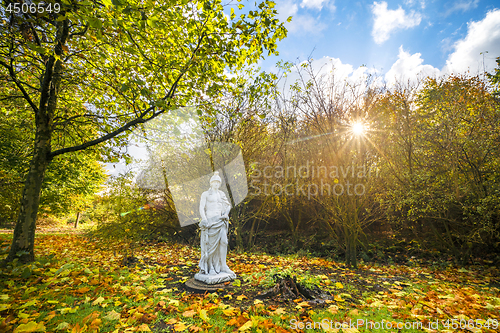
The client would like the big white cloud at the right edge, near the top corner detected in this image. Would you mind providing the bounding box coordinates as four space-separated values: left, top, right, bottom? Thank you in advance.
443 9 500 74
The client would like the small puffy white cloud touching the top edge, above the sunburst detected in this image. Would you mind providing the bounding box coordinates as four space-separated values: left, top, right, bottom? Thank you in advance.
372 1 422 44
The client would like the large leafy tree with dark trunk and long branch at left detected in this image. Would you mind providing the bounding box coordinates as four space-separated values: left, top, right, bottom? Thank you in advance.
0 0 286 261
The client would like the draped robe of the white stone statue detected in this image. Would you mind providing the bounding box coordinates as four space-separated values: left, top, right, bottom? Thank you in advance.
199 190 231 274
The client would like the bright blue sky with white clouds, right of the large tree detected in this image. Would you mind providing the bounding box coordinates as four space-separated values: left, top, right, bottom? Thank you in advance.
250 0 500 81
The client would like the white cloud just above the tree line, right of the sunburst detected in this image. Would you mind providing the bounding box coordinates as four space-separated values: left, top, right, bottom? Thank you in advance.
385 45 440 85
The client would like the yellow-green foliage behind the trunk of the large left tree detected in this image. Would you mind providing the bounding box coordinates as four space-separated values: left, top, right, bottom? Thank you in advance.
0 98 105 224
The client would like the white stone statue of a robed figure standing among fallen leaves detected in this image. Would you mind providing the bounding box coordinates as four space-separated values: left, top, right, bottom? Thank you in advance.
194 171 236 284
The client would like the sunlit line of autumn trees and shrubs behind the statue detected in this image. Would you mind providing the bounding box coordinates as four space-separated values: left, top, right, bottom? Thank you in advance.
76 62 500 266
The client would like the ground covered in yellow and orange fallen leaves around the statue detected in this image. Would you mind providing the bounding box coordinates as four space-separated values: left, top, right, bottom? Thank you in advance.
0 234 500 333
